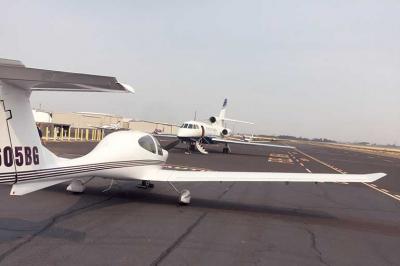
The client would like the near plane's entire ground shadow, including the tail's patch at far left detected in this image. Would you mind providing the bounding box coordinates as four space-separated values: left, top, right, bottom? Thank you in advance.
0 181 400 247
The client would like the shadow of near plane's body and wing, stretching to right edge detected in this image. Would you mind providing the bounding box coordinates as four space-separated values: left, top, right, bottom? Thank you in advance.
52 182 400 237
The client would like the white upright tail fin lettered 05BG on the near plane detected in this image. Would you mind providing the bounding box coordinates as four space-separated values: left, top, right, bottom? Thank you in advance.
0 59 54 187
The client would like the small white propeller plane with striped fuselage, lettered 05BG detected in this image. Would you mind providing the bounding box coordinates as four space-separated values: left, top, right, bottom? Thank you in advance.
0 59 385 204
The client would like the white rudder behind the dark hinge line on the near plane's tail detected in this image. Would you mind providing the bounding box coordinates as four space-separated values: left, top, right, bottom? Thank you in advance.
0 99 17 183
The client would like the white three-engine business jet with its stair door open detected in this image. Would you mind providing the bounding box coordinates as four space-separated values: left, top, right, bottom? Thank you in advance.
159 99 295 154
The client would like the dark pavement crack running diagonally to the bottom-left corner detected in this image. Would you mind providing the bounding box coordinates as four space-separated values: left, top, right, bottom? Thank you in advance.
0 197 113 263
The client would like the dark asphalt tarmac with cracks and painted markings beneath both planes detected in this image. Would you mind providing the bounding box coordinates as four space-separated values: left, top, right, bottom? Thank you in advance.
0 140 400 265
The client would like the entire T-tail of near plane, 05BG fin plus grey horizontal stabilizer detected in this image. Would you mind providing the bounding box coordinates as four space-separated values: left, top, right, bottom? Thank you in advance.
0 59 133 187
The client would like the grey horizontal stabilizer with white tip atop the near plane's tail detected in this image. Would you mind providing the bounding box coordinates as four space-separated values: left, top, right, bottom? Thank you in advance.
0 59 134 93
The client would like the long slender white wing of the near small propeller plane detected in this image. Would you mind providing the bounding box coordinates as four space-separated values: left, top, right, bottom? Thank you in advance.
146 170 386 183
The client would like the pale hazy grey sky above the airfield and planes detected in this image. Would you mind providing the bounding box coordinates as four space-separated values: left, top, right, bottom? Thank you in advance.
0 0 400 144
